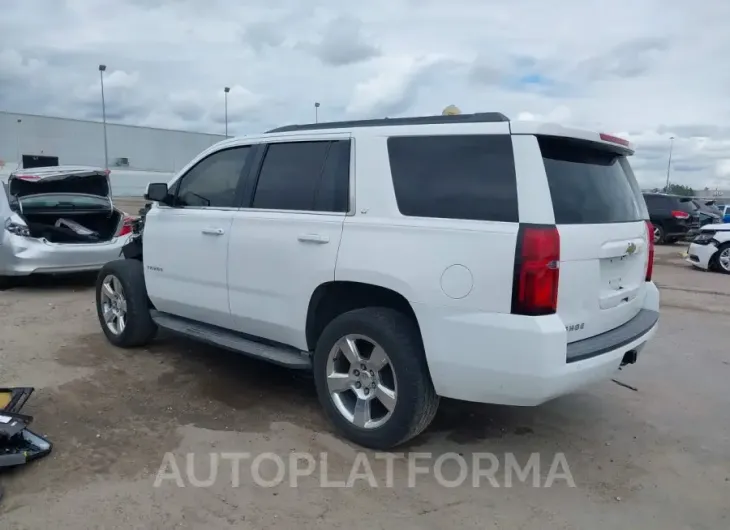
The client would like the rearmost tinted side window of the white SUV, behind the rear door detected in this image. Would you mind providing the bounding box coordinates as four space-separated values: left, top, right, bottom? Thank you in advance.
388 135 519 222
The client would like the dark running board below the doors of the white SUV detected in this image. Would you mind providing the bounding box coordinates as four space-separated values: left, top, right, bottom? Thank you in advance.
150 310 312 370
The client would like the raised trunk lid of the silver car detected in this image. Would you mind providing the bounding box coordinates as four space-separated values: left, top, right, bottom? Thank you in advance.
8 166 111 198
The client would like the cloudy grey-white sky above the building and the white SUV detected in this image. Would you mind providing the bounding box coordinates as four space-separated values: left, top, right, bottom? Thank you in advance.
0 0 730 188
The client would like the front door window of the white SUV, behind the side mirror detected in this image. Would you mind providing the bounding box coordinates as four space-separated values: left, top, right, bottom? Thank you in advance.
173 146 251 208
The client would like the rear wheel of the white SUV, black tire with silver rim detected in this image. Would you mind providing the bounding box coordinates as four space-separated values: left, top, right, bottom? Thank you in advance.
313 307 439 450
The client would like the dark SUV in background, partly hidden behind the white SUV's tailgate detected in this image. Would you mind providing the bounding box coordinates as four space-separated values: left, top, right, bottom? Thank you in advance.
644 193 700 244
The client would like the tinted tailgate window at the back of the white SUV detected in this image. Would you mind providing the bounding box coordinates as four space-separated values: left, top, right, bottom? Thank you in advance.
538 137 643 224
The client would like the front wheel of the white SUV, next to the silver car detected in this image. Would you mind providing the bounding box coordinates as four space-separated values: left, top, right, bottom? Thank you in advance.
96 259 157 348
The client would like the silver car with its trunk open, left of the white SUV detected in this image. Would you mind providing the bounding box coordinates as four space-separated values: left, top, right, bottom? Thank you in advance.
0 166 135 286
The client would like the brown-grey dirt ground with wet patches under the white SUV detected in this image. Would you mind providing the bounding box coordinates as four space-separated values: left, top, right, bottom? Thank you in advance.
0 240 730 530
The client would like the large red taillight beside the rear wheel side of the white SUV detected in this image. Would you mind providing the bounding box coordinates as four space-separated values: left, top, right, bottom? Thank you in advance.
512 225 560 316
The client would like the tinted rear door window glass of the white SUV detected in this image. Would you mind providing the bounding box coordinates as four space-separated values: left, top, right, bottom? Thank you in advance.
252 140 350 212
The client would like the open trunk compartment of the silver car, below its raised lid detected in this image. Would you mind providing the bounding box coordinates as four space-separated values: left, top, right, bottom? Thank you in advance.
22 210 122 243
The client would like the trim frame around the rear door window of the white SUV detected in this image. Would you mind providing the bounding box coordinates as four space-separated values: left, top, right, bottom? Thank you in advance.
240 133 356 217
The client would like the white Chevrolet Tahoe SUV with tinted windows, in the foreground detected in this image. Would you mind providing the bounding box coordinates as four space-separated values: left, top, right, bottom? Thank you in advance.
96 113 659 449
